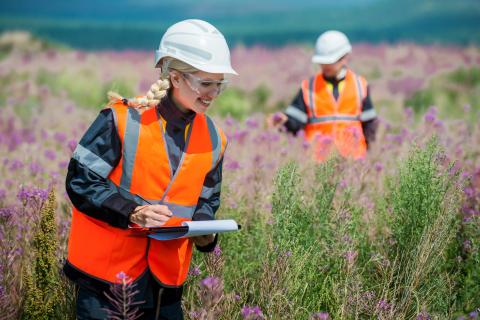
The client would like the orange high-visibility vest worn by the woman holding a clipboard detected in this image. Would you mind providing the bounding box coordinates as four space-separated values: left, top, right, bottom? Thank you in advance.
67 101 226 287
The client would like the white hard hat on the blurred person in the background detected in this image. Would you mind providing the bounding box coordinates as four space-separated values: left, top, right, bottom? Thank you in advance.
312 30 352 64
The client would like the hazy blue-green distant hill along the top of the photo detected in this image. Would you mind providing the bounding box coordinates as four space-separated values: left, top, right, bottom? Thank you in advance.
0 0 480 49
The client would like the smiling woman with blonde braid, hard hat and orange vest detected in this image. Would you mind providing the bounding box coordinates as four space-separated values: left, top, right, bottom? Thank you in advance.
64 20 236 319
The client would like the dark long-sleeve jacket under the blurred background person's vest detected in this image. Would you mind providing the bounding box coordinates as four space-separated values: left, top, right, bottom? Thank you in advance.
284 70 378 146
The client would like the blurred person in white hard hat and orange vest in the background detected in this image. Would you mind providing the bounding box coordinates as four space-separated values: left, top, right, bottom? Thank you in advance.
267 30 377 161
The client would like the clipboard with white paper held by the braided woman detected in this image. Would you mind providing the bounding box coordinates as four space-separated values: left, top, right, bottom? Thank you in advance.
148 220 240 240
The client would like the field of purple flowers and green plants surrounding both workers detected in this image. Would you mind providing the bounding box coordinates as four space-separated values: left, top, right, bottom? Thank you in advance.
0 33 480 319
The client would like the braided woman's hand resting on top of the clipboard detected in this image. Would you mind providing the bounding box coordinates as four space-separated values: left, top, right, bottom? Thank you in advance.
130 204 173 228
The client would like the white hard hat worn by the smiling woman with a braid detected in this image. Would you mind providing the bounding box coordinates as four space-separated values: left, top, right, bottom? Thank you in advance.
155 19 237 74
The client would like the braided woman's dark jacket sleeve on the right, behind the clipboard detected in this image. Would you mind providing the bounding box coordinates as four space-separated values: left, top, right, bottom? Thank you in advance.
192 158 223 252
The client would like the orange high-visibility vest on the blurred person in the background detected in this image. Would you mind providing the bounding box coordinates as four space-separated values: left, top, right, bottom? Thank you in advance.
302 70 367 161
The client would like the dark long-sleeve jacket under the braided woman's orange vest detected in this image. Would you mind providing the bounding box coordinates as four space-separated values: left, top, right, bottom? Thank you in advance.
66 96 223 251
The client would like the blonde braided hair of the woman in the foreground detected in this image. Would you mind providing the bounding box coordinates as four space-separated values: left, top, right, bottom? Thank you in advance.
107 57 199 109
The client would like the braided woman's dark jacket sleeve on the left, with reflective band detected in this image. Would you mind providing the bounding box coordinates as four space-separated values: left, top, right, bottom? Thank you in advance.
65 109 138 228
